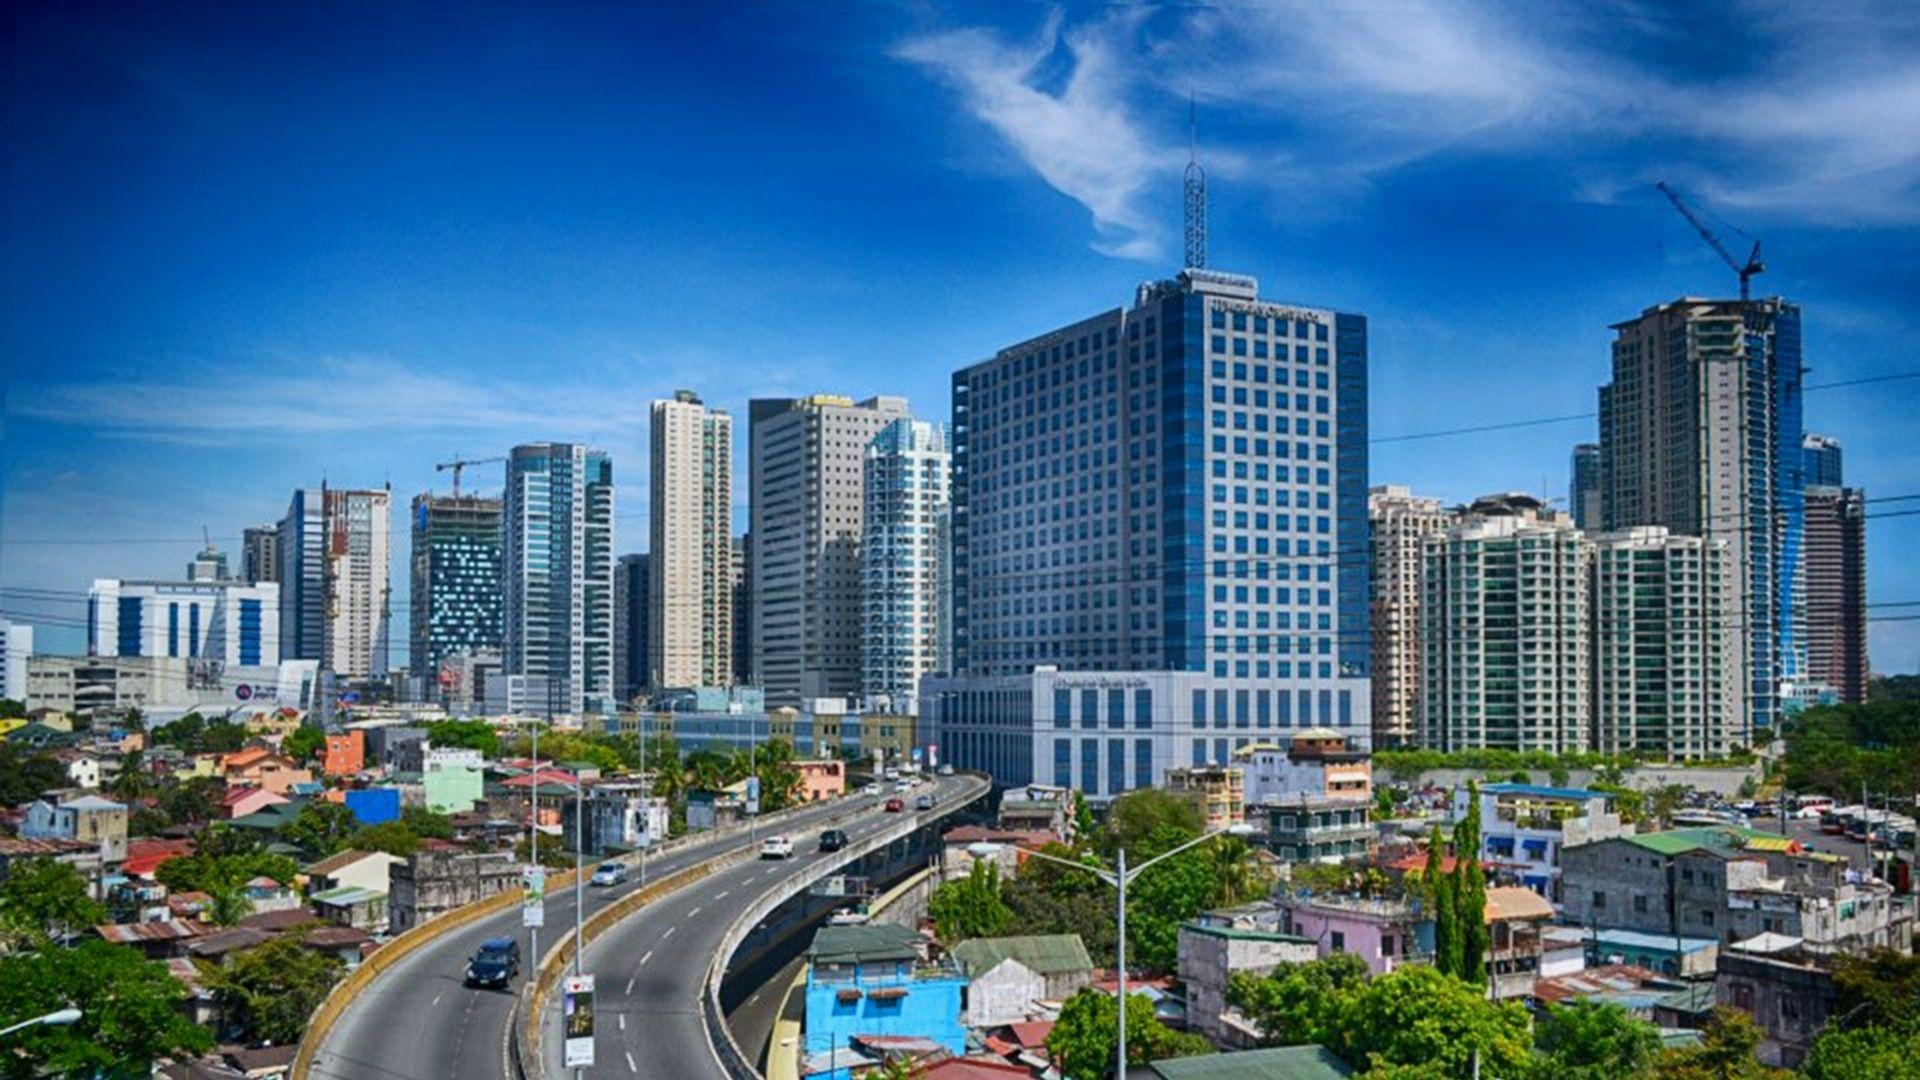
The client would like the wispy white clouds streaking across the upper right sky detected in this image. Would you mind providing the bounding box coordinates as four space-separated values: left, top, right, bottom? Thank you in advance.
897 0 1920 256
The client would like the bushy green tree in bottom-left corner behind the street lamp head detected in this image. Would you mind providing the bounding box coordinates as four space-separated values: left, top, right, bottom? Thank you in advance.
0 942 213 1080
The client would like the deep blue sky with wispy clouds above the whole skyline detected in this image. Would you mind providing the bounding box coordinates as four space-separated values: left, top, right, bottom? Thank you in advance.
0 0 1920 671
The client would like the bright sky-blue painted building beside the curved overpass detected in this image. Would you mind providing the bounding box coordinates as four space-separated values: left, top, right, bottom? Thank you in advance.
804 924 966 1080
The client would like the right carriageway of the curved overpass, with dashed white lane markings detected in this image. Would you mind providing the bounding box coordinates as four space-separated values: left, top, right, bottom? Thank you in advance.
541 776 985 1080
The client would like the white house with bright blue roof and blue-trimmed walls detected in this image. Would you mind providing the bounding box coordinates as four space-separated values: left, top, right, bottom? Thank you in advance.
1452 784 1634 905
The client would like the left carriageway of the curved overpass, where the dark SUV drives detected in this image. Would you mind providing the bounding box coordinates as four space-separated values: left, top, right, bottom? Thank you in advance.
311 796 902 1080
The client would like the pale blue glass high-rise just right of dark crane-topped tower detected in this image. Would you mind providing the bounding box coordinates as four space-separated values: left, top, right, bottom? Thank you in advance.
501 442 614 715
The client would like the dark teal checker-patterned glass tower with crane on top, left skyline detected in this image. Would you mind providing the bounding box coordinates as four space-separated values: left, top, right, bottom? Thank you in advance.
407 492 505 686
